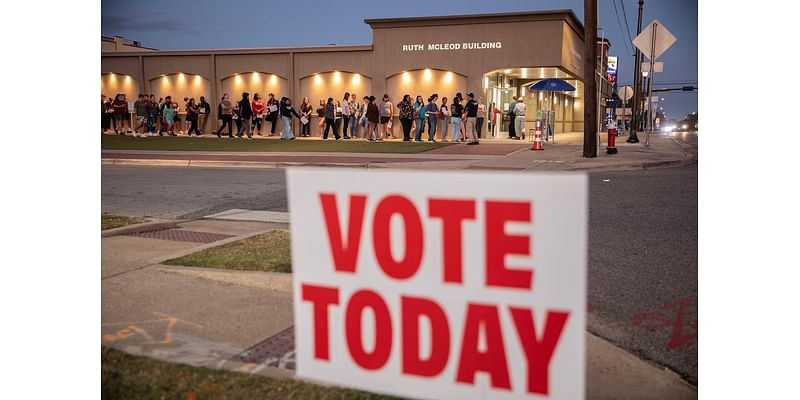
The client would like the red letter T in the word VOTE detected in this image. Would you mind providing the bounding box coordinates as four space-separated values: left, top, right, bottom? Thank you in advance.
428 199 475 283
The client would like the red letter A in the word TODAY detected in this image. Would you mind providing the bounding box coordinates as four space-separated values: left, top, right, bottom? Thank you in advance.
456 304 511 389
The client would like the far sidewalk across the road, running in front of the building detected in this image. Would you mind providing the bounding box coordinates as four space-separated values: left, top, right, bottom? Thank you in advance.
102 133 697 171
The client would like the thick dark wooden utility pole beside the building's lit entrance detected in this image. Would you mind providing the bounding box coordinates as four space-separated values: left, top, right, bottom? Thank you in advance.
583 0 597 158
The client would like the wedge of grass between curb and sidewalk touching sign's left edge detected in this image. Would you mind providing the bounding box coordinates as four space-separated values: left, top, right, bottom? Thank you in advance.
164 230 292 272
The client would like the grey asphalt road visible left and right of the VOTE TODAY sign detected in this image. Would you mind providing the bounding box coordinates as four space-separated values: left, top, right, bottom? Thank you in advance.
102 162 698 385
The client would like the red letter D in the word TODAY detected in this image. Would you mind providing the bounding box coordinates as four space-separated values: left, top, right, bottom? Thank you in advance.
400 296 450 376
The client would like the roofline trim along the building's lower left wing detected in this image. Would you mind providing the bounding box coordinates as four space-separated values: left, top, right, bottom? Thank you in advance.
100 44 372 57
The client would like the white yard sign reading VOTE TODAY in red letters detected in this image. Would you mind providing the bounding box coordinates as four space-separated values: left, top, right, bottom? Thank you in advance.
287 169 588 399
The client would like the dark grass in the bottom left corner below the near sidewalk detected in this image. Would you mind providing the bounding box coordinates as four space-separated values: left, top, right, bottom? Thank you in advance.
100 348 394 400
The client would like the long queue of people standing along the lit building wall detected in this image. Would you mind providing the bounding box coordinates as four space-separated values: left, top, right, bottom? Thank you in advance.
101 92 510 145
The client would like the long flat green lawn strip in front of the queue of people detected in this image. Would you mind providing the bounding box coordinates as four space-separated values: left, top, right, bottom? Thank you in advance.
100 134 451 154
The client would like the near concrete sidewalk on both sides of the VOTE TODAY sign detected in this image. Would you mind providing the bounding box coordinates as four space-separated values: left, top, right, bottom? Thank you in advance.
101 217 697 399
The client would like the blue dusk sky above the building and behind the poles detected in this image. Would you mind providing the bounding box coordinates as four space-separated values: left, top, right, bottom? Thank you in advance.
101 0 698 119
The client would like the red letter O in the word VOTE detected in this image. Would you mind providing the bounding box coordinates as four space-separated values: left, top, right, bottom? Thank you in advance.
372 195 424 279
